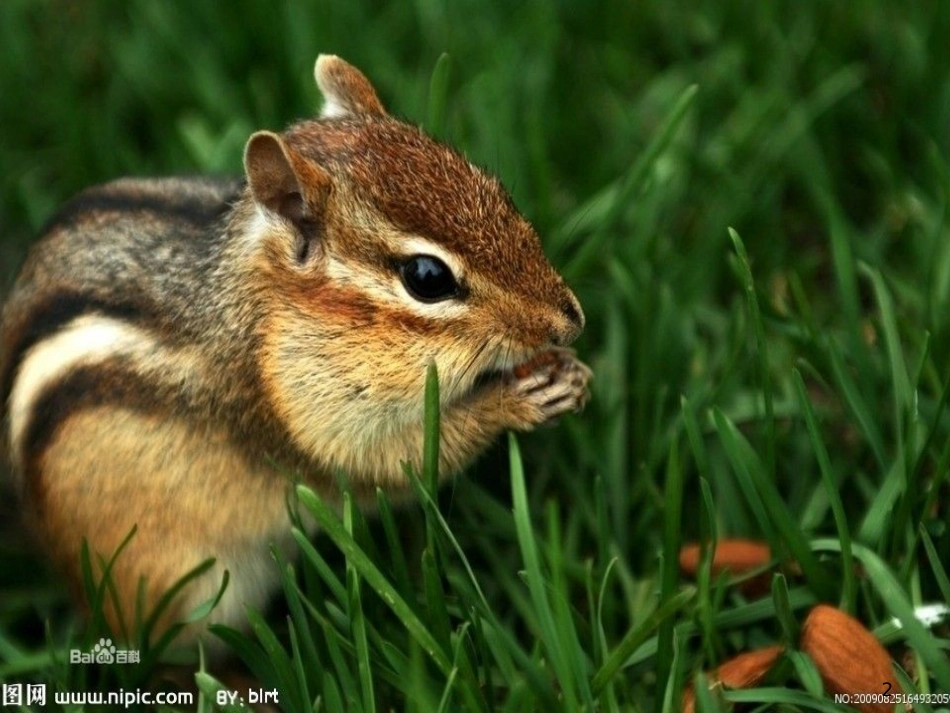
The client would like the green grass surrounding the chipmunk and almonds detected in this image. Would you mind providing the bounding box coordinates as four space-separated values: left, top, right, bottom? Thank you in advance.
0 0 950 713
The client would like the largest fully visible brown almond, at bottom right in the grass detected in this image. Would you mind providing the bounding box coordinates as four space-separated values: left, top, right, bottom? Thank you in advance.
800 604 901 713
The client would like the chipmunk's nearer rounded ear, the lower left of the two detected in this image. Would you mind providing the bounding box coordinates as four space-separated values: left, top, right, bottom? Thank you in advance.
244 131 333 227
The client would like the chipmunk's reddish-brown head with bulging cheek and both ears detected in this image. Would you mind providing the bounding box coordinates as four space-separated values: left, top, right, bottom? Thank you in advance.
245 55 584 482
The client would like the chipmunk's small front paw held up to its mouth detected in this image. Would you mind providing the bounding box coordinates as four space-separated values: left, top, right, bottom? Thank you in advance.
505 349 591 430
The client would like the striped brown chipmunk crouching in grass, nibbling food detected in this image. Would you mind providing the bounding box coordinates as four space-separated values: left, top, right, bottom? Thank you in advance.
0 55 591 636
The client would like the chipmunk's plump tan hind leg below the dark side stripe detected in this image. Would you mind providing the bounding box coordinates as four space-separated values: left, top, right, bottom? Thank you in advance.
31 407 289 643
